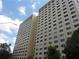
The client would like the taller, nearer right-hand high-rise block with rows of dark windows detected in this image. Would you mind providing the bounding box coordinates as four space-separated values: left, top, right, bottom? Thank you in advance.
34 0 79 59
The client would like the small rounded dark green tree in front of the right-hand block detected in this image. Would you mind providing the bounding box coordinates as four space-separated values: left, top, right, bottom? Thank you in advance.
47 46 60 59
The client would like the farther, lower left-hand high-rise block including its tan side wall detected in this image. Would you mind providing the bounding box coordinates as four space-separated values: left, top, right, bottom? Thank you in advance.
13 15 37 59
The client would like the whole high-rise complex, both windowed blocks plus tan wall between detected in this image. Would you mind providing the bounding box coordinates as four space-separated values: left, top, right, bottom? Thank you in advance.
13 0 79 59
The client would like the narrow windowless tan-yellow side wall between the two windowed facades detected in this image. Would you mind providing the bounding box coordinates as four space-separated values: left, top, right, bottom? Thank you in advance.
27 15 37 58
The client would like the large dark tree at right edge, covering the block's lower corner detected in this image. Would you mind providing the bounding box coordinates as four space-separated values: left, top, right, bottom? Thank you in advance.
64 29 79 59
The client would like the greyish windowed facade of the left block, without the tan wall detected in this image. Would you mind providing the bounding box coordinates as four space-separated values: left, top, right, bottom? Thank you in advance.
13 16 32 59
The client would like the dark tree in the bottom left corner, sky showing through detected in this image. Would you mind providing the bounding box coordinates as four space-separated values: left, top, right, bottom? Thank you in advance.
0 43 11 59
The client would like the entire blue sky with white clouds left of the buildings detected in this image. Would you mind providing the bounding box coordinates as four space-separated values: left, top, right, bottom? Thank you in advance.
0 0 48 49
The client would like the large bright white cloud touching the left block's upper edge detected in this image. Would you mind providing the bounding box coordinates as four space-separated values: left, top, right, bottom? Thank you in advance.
0 15 22 33
